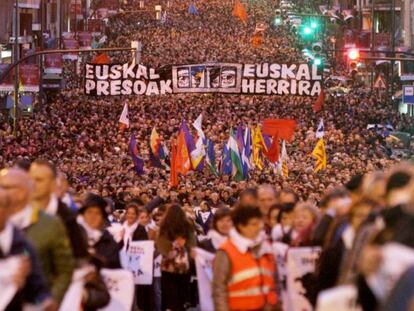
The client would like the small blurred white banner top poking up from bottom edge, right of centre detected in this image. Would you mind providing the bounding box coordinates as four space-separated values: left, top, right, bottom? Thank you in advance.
316 285 362 311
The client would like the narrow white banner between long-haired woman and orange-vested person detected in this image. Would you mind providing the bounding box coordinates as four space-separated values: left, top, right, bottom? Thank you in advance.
195 247 215 311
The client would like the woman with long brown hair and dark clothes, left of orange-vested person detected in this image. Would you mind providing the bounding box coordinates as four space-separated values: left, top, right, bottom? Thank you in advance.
156 204 196 311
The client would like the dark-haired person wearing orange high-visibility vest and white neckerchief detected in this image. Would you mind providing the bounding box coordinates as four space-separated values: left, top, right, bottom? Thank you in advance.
212 206 277 311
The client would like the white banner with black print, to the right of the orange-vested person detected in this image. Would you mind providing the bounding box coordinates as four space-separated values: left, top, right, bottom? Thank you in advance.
284 247 321 311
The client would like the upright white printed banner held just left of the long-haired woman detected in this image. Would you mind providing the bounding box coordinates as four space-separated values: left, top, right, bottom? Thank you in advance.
126 241 155 285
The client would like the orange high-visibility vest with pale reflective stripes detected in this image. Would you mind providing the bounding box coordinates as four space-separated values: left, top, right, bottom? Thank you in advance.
220 240 277 310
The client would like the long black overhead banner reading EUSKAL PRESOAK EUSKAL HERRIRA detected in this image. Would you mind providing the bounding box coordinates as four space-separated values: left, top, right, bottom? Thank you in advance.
84 63 322 96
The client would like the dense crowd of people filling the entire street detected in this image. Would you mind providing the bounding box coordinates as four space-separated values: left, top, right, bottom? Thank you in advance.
0 0 414 311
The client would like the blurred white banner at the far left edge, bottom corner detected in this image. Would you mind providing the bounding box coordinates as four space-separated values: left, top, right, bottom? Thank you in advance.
0 256 20 310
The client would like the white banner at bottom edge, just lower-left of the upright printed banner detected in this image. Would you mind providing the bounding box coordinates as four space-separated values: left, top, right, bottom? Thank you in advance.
100 269 135 311
